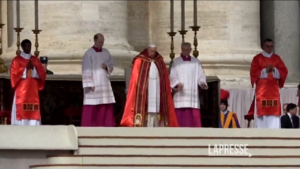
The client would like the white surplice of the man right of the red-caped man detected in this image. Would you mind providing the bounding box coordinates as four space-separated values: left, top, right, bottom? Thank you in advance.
170 57 207 109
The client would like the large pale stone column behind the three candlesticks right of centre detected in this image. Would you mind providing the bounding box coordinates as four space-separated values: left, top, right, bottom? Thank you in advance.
150 1 261 85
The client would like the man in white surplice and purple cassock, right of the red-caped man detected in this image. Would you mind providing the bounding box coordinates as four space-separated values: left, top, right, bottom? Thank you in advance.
170 42 208 127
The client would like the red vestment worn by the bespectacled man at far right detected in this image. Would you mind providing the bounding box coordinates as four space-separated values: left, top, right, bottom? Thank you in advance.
248 54 288 116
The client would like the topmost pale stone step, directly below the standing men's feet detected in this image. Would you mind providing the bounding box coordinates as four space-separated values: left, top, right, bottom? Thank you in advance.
76 127 300 140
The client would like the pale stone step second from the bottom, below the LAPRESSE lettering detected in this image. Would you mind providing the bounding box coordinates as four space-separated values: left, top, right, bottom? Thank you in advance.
47 155 300 167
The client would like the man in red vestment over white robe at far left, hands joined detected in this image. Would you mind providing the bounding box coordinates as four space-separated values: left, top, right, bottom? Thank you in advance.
10 39 46 126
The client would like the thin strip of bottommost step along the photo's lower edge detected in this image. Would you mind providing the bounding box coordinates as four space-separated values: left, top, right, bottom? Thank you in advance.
30 164 297 169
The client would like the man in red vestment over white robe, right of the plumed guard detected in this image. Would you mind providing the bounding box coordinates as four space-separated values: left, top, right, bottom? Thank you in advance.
248 39 288 129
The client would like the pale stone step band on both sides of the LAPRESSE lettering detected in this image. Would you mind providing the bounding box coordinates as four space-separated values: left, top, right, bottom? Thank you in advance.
77 146 300 156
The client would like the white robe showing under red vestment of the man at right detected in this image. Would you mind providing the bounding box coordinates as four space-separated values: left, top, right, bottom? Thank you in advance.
254 51 281 129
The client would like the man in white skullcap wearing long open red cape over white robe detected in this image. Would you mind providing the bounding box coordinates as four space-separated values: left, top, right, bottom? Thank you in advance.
121 45 178 127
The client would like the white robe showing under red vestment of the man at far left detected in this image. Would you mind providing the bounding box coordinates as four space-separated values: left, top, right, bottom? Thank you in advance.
11 52 41 126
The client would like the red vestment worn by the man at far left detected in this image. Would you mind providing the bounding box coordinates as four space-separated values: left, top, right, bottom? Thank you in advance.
10 56 46 120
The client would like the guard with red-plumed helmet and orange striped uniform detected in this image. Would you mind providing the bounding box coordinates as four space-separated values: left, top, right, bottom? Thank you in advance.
219 89 240 128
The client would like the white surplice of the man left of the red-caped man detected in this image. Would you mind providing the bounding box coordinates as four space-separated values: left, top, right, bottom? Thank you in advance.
82 48 115 105
